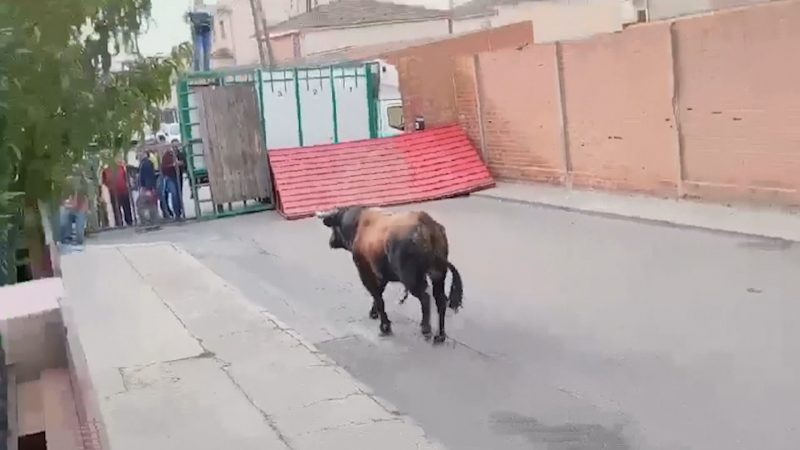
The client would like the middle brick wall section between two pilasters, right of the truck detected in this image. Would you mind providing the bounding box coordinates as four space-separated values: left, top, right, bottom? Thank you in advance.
562 22 679 195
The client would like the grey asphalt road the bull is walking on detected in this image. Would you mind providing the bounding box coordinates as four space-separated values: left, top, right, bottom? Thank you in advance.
94 197 800 450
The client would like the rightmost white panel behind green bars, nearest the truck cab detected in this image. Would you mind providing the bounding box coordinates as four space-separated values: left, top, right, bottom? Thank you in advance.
333 67 369 142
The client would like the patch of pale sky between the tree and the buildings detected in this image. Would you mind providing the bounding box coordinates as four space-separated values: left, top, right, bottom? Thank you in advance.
139 0 198 56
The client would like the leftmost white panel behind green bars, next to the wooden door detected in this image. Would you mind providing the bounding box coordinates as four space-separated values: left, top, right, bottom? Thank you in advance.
261 70 300 150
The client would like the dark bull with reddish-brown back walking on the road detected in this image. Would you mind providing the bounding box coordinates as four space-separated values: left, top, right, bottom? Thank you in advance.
317 206 464 344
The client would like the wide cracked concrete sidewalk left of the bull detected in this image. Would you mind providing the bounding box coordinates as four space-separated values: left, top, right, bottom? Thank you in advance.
62 244 444 450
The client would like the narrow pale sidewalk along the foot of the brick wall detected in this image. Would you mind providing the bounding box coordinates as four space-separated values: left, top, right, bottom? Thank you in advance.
472 183 800 241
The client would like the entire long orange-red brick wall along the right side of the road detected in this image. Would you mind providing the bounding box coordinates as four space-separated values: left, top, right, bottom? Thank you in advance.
424 1 800 206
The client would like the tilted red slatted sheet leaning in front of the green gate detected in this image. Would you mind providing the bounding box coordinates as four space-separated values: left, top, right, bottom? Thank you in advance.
269 125 494 219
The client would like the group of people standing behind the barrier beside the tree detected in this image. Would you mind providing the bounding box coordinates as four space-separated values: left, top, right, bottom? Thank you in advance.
60 142 186 247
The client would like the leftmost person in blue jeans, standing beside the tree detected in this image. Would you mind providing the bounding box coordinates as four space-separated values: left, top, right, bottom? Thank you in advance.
59 170 89 250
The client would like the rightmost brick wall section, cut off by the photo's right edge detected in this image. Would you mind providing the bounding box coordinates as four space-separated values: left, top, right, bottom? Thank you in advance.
675 2 800 204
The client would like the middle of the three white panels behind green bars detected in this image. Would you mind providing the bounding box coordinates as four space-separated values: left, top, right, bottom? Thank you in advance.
297 69 335 147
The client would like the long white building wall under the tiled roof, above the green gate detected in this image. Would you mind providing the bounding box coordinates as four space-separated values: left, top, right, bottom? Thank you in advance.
301 19 448 55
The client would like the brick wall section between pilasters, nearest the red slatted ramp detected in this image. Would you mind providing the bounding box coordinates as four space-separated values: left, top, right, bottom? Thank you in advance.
478 44 566 182
